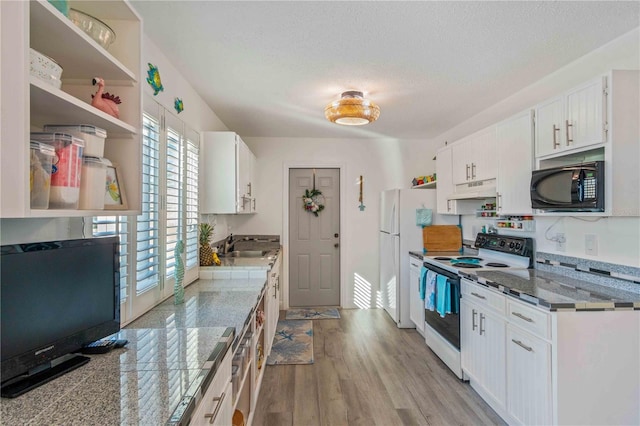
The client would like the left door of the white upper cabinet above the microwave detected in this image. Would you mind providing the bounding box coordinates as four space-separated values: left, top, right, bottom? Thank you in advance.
535 97 564 157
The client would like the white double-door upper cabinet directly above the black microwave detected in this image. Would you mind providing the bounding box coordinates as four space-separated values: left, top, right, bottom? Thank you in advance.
536 77 607 157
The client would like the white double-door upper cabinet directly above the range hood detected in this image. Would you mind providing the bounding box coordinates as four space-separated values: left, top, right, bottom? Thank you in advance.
453 126 497 185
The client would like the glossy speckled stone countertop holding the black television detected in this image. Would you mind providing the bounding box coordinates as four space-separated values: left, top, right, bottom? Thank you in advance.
0 279 266 425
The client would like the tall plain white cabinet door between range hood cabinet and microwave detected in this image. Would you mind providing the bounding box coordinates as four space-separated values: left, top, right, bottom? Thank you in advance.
496 110 533 215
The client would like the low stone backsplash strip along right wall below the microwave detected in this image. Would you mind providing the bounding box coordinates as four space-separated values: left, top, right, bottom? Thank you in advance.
535 252 640 294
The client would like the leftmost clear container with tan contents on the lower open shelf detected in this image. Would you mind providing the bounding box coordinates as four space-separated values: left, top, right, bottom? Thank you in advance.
29 141 56 209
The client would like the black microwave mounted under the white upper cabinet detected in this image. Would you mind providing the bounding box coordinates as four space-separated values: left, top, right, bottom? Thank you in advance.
531 161 604 212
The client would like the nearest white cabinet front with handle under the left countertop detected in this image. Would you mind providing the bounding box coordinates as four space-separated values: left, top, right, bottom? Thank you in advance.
189 349 233 426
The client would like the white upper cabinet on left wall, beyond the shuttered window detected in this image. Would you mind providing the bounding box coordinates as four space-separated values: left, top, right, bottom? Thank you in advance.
200 132 256 214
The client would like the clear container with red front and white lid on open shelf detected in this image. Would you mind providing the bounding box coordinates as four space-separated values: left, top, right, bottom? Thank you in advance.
31 132 84 210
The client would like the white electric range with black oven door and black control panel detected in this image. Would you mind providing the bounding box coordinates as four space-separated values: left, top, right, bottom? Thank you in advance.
423 233 534 379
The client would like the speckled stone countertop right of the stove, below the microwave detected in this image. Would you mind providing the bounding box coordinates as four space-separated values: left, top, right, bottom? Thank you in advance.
462 269 640 311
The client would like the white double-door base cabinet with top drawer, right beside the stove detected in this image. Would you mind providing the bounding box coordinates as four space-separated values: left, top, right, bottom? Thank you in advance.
460 279 506 411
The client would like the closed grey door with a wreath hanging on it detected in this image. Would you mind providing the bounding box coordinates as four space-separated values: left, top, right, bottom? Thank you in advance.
288 168 340 307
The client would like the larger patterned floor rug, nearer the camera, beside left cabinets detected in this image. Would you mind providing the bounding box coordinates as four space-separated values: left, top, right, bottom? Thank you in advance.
267 320 313 365
